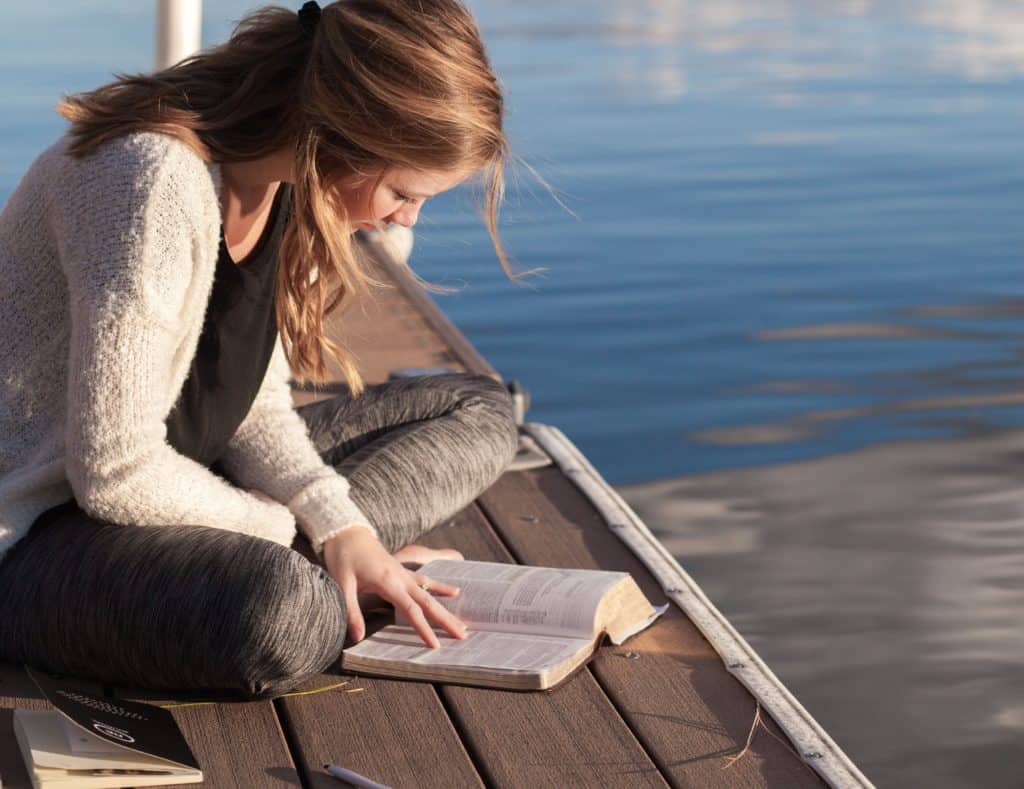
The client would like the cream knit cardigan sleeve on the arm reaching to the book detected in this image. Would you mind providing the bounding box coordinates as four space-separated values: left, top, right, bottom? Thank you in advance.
220 337 379 555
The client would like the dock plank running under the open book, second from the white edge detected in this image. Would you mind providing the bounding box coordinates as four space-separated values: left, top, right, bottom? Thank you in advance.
419 505 667 787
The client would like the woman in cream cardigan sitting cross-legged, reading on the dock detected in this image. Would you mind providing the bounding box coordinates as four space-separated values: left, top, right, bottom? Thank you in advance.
0 0 516 697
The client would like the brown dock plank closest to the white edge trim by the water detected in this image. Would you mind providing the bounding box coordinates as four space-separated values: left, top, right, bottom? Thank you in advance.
479 468 821 787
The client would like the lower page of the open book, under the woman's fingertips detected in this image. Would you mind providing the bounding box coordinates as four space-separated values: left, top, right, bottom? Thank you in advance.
345 624 591 673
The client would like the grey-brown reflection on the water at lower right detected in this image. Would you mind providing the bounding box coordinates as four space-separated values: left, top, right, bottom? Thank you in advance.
620 431 1024 788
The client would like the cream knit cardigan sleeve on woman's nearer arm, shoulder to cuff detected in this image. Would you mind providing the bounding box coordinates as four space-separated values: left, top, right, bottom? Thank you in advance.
61 134 295 545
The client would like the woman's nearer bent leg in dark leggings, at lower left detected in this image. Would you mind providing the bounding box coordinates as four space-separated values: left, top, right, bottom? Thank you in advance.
0 511 346 697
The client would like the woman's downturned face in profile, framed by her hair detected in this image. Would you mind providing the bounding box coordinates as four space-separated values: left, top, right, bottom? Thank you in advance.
342 167 469 231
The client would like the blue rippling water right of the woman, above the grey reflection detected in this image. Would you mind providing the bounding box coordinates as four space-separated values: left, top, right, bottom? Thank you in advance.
416 2 1024 482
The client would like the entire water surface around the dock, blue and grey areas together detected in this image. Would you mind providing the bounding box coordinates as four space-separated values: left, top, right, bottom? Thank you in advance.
0 0 1024 787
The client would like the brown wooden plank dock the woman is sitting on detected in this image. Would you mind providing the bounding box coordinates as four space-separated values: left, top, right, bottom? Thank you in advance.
0 237 856 789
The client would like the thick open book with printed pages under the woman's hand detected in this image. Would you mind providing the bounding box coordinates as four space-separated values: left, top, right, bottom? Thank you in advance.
342 559 668 690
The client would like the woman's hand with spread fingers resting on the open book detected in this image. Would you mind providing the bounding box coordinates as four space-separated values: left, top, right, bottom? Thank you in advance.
324 526 466 649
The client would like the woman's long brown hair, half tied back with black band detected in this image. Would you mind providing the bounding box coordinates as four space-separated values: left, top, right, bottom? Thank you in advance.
57 0 519 393
